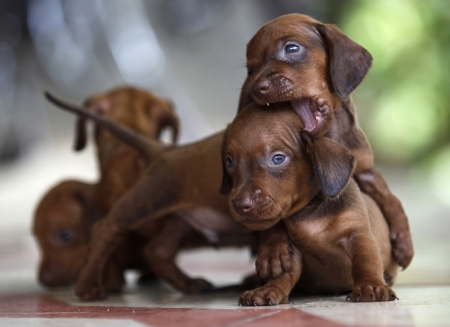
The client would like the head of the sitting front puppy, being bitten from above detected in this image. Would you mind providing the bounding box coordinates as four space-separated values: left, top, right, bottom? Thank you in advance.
221 104 354 230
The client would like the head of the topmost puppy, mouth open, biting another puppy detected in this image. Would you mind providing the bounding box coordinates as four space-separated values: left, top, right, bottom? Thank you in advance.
240 14 372 135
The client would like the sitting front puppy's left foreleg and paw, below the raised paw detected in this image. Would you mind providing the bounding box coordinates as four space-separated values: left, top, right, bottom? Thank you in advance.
238 246 302 306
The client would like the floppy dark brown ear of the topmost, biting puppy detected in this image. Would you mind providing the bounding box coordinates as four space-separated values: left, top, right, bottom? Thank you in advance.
316 24 372 99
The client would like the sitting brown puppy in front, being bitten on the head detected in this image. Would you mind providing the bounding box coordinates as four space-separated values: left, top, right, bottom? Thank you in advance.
221 104 398 305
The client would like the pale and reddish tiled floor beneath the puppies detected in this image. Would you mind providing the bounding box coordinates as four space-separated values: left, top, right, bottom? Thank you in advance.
0 239 450 327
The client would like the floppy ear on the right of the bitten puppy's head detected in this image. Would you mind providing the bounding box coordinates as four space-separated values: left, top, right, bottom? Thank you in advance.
302 132 355 198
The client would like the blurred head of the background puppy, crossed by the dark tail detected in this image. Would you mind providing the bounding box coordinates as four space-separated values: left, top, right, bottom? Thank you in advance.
75 87 180 151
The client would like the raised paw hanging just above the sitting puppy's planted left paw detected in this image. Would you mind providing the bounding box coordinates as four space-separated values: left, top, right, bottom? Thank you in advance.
255 244 292 279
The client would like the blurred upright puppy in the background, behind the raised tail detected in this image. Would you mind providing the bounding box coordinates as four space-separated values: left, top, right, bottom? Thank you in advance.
75 87 179 214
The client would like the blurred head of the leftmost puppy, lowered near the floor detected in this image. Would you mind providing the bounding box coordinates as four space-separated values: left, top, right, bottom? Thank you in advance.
33 181 92 286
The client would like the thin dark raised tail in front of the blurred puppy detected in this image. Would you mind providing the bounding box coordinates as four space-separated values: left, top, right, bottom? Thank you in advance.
45 92 161 163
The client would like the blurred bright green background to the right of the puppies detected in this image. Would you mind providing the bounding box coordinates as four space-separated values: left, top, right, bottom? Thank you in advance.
327 0 450 208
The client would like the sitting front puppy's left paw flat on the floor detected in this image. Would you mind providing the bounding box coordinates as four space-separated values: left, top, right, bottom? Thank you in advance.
238 283 293 307
